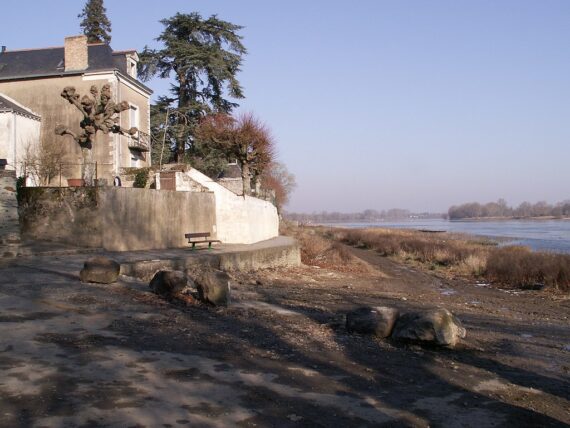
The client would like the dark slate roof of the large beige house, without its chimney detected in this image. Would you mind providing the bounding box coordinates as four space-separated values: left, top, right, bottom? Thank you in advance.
0 43 152 94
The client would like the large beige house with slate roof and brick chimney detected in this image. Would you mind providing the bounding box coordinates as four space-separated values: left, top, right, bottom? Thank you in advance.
0 36 152 184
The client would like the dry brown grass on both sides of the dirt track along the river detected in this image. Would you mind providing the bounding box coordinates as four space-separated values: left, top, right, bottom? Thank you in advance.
281 225 570 292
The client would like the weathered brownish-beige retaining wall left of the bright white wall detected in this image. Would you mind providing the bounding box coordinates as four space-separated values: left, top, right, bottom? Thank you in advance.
20 187 216 251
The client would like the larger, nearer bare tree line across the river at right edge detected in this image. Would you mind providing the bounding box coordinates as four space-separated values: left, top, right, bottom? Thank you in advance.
448 199 570 220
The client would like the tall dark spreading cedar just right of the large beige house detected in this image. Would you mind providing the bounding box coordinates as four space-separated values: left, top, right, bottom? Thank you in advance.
139 13 246 162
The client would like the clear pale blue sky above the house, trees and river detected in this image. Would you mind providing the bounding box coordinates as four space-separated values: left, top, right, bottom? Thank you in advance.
0 0 570 213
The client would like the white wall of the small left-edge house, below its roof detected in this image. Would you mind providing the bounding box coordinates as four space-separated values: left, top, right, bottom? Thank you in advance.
0 111 41 174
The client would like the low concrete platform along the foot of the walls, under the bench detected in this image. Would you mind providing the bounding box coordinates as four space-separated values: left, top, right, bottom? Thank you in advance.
5 236 301 281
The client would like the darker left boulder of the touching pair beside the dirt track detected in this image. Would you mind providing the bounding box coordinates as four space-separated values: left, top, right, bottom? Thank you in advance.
346 306 399 337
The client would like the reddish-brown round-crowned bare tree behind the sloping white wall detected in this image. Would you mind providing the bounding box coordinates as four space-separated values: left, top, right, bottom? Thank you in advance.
195 113 275 195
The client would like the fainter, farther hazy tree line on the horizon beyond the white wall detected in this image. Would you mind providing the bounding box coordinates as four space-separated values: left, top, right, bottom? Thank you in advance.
285 208 442 223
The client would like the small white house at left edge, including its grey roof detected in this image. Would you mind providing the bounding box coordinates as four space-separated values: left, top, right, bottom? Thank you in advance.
0 93 41 175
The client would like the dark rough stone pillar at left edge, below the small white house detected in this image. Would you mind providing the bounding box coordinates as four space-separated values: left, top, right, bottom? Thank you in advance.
0 171 21 258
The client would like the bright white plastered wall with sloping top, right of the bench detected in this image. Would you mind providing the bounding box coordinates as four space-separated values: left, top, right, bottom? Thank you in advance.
157 168 279 244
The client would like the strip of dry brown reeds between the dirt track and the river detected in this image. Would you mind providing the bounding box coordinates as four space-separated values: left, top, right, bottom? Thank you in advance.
286 227 570 293
